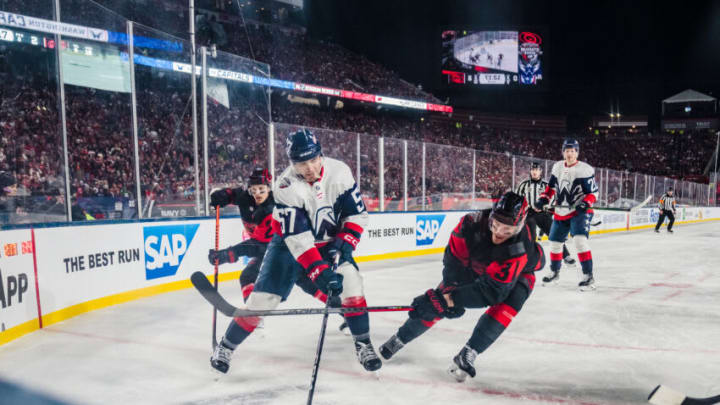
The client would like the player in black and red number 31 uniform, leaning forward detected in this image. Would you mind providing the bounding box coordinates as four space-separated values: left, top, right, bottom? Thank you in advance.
380 192 545 382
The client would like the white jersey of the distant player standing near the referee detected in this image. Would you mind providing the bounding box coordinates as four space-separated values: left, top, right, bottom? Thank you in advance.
543 160 598 220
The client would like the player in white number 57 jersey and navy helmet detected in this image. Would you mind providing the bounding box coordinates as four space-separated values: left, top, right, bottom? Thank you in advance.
210 129 382 373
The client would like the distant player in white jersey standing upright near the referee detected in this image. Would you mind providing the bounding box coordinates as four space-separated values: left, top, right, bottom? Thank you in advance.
536 139 598 291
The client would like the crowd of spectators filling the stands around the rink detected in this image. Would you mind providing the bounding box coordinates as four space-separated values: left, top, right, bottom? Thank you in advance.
0 0 714 221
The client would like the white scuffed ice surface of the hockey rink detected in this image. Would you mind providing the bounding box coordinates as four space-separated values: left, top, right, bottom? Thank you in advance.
0 222 720 405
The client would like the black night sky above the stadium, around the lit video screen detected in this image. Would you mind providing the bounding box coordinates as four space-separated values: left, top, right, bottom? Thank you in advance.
305 0 720 126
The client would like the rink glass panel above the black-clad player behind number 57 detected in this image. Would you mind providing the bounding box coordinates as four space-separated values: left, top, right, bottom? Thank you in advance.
205 51 270 213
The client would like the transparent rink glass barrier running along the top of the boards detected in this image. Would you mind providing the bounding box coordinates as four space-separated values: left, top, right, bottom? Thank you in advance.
0 0 717 223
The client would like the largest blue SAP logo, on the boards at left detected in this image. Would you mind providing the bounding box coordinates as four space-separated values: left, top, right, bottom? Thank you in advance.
143 224 200 280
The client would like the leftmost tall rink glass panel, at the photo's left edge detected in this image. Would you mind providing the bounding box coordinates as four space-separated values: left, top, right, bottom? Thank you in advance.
0 0 67 225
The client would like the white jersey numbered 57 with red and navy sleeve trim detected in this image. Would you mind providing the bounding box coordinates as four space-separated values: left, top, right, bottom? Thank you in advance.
273 157 368 270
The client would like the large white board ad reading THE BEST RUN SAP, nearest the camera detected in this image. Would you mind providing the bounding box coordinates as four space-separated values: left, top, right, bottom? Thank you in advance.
36 218 249 314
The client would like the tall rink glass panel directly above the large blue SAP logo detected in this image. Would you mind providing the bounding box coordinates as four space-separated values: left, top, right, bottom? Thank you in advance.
134 24 202 218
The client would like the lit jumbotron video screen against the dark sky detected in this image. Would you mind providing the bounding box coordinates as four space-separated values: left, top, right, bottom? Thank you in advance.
442 30 545 88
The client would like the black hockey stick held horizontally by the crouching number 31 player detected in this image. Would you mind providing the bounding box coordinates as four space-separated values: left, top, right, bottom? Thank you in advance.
190 271 412 318
